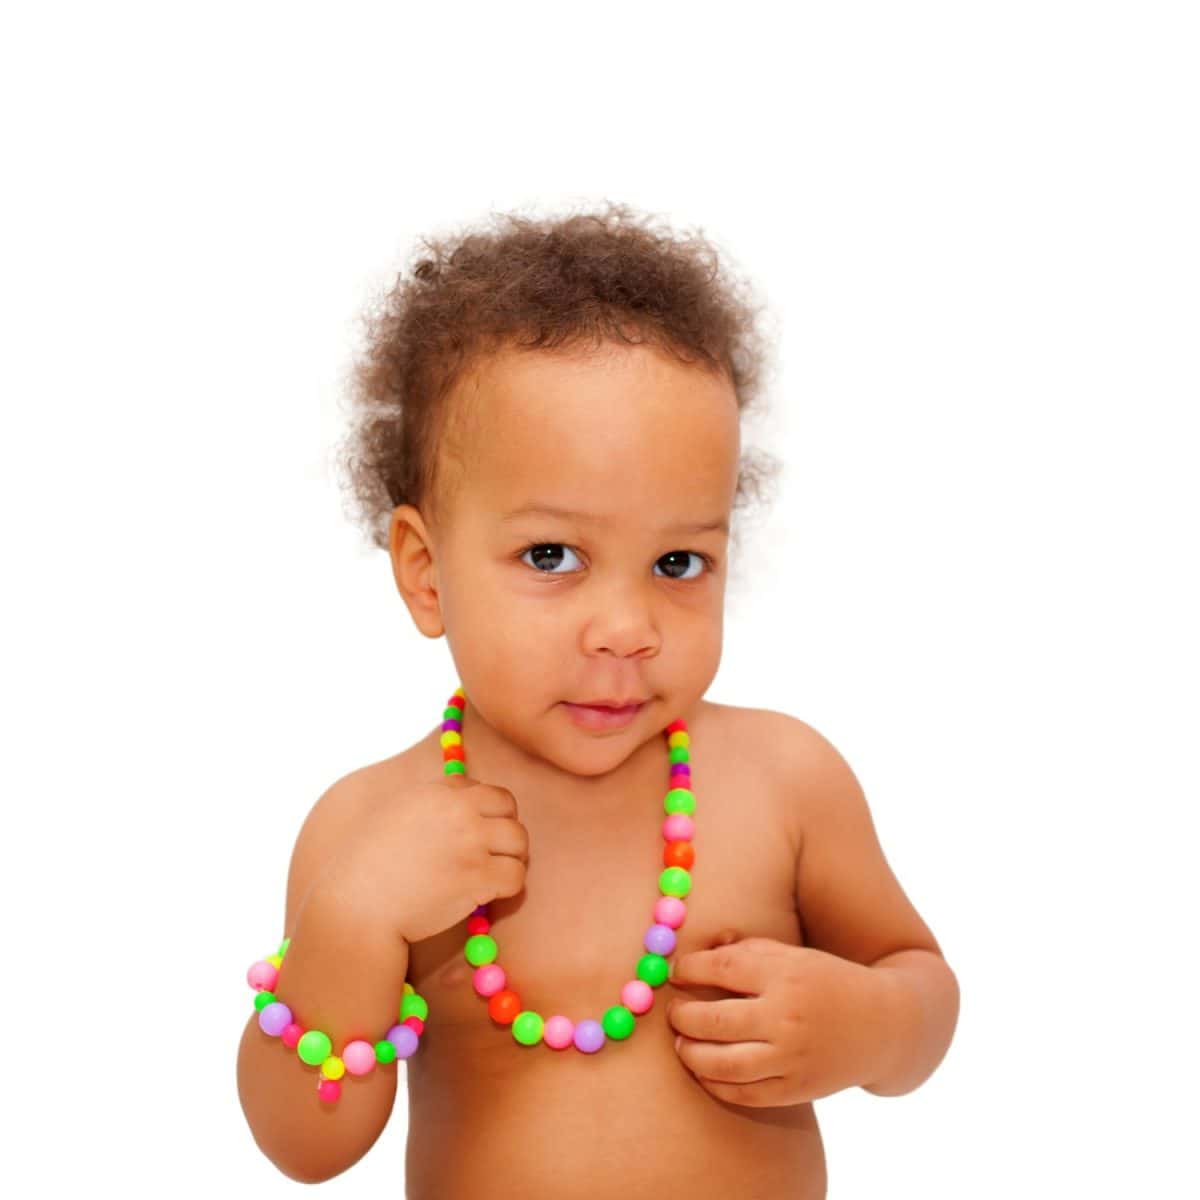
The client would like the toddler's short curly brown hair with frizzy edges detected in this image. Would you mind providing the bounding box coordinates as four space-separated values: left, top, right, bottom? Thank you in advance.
336 202 780 561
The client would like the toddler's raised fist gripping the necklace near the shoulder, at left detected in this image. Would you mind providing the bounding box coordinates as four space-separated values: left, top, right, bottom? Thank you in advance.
326 775 529 943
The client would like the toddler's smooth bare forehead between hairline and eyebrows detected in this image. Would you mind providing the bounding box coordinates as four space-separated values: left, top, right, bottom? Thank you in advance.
446 346 739 520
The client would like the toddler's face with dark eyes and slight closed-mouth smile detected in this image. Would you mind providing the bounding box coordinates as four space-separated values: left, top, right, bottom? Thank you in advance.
392 346 740 775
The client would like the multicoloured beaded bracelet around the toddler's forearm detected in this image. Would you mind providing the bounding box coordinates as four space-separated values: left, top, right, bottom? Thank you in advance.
246 937 430 1103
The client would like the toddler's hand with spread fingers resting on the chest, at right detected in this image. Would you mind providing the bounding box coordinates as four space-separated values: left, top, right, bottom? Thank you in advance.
667 937 888 1108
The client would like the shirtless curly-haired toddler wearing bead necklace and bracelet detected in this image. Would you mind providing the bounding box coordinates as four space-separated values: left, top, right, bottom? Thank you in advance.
238 205 959 1200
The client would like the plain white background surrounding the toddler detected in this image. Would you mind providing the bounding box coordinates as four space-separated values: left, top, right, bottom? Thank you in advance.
0 0 1200 1200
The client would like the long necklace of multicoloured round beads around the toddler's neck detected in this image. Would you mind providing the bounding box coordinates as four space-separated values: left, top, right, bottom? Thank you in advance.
441 688 696 1054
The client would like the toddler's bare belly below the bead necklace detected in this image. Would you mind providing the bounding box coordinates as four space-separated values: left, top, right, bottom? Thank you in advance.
404 984 826 1200
